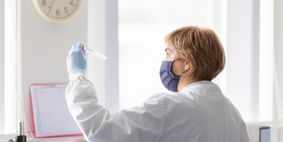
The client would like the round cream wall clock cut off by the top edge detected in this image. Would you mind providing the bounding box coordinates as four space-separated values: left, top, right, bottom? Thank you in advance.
33 0 82 23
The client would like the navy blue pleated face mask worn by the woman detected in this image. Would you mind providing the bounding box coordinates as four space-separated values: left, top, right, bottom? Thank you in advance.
159 59 180 92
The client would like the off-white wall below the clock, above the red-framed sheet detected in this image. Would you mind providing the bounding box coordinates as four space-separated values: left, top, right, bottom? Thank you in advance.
18 0 88 133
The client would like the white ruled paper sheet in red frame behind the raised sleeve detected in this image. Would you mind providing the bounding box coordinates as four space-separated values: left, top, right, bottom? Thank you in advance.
30 84 81 137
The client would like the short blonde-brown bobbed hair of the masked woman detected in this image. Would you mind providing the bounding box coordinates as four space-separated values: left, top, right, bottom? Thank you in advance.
164 26 226 81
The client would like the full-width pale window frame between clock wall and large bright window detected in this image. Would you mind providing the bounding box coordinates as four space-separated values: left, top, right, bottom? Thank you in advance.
87 0 119 112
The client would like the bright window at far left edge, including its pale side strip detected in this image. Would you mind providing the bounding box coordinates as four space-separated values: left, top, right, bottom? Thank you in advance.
0 0 17 134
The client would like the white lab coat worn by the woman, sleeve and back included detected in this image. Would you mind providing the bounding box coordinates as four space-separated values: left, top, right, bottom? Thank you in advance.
66 70 249 142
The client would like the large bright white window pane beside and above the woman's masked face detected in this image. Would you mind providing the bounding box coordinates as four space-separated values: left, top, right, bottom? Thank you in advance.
118 0 207 109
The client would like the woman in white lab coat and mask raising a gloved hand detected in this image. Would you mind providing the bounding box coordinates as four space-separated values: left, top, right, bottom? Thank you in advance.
66 26 249 142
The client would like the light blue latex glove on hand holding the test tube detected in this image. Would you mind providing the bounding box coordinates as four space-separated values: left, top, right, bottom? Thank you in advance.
67 42 87 74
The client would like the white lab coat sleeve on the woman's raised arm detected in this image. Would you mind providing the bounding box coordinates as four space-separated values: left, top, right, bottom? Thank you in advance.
66 70 165 142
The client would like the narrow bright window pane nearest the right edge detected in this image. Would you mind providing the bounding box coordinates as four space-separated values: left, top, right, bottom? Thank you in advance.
259 0 275 121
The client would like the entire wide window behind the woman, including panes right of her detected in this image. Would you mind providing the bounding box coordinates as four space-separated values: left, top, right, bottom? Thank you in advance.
118 0 281 121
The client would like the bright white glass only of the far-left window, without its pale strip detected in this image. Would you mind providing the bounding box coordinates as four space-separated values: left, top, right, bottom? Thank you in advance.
4 0 17 134
